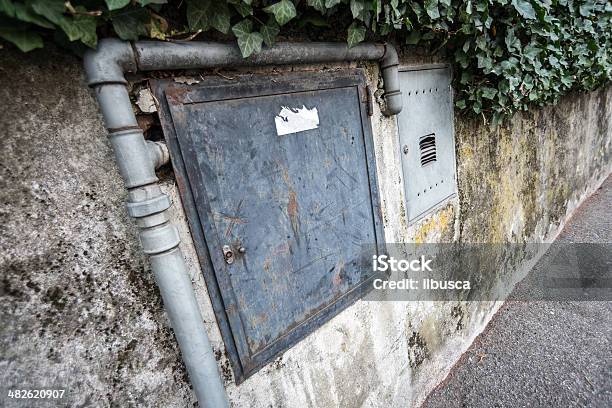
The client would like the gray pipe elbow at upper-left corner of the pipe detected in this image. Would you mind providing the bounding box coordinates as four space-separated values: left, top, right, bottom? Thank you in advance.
83 38 137 87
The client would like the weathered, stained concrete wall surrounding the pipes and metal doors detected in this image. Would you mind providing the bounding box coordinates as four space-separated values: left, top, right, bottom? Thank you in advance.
0 45 612 407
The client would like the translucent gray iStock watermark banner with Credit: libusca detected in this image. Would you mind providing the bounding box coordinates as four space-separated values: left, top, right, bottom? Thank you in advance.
359 243 612 301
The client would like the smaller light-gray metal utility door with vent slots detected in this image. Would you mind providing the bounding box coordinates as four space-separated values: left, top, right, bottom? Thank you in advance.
398 66 457 222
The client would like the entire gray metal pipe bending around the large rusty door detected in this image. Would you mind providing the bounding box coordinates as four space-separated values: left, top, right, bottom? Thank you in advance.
84 39 402 408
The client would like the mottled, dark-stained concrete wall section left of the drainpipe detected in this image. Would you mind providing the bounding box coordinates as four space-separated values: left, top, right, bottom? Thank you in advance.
0 50 194 407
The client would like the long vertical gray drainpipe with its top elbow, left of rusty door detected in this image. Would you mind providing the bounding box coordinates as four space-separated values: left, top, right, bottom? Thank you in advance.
85 40 229 408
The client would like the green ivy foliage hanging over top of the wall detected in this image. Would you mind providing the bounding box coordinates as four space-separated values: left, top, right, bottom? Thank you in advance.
0 0 612 124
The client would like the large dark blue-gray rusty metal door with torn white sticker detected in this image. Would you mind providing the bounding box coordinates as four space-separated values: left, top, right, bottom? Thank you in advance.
153 70 384 382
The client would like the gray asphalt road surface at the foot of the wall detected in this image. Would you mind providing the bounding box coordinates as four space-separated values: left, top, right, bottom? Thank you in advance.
423 176 612 408
